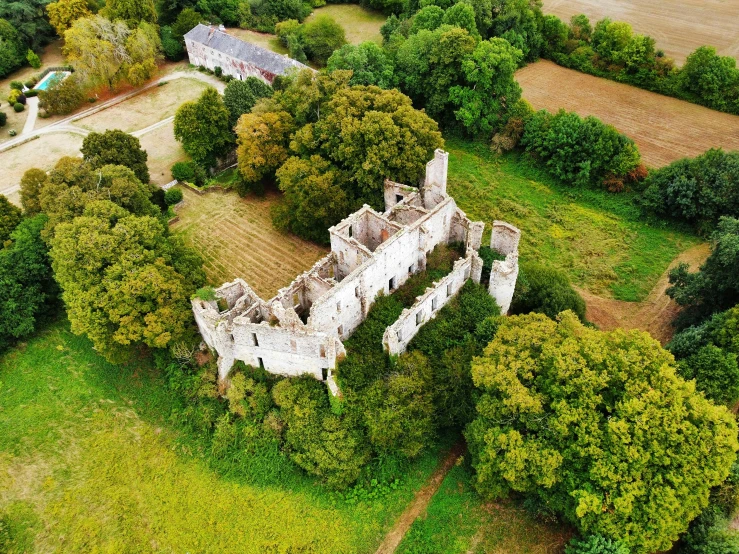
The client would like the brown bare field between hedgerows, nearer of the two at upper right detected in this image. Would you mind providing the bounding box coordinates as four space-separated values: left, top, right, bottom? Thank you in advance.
516 60 739 167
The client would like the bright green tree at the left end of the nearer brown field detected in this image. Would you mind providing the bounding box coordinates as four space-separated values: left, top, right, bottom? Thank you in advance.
449 38 521 136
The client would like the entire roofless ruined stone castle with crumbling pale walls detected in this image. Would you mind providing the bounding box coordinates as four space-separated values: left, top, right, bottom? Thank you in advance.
192 150 521 394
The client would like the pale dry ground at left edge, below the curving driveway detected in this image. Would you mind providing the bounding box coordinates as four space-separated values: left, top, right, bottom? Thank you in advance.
0 133 82 204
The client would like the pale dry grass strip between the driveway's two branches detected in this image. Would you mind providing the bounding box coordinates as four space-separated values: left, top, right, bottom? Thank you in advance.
75 79 208 133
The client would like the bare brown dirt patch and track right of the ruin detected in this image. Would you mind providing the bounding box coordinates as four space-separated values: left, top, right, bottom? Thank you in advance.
578 244 711 344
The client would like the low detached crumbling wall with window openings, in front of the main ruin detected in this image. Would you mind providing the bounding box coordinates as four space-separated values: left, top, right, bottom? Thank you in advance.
382 250 482 355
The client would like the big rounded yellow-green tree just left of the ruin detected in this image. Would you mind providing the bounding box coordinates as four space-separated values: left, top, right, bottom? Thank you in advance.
50 200 204 363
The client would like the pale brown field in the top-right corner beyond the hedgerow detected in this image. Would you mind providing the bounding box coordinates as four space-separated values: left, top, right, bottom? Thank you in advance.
544 0 739 65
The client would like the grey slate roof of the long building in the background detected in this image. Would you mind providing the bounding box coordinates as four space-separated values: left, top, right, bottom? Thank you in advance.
185 23 310 75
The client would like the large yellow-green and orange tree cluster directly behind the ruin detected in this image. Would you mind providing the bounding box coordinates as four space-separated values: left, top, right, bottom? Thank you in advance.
236 71 442 242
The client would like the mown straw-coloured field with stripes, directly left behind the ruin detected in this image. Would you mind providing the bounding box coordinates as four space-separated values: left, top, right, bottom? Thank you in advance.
172 187 328 299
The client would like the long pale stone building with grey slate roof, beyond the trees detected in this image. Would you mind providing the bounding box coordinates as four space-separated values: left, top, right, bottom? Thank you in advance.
185 24 310 84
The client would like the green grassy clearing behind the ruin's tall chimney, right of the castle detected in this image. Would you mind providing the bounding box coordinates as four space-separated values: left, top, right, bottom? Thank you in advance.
447 140 701 301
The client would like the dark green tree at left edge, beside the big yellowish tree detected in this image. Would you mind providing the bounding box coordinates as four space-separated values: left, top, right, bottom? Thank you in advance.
0 215 58 350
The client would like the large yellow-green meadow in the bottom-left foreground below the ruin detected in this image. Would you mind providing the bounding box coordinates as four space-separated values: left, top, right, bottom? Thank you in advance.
0 322 454 554
